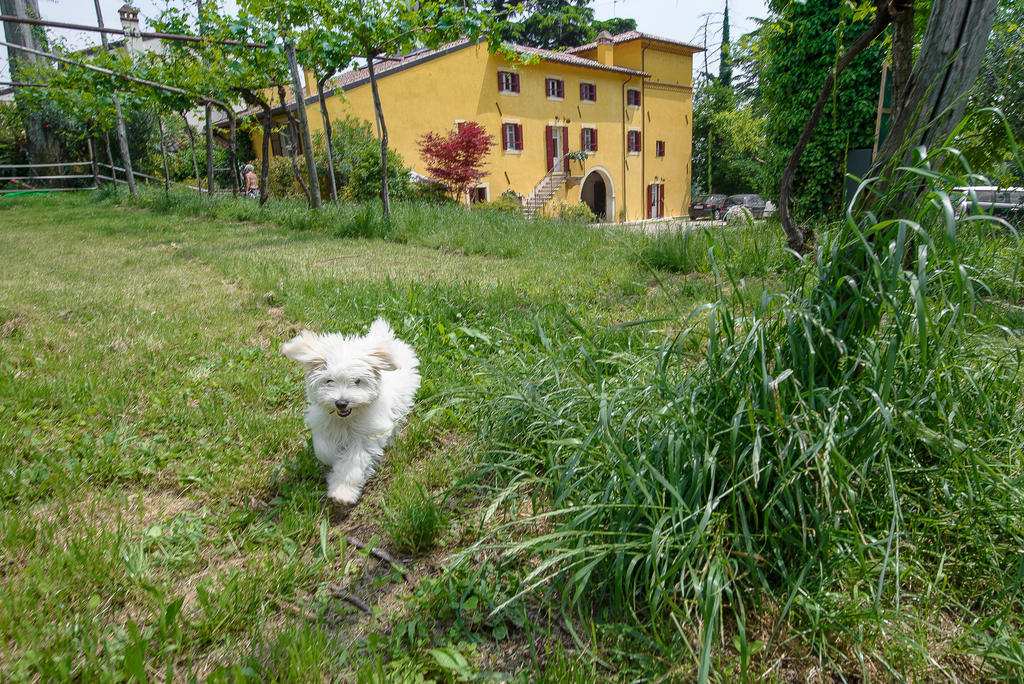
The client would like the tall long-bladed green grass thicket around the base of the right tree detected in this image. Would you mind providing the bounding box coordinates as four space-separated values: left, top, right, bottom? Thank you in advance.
466 145 1024 680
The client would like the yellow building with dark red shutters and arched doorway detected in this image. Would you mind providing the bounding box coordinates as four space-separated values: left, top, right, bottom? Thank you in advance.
253 31 701 220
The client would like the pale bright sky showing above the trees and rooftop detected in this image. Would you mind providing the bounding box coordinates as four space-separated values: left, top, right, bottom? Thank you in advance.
0 0 768 81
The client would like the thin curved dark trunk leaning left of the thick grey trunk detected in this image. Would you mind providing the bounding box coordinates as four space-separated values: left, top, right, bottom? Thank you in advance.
778 0 890 252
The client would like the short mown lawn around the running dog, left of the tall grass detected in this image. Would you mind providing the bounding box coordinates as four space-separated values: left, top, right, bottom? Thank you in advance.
0 189 708 681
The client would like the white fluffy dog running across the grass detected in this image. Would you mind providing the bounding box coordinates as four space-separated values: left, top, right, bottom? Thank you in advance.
281 318 420 505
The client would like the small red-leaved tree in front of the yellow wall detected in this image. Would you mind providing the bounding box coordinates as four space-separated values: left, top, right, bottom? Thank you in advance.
419 121 495 203
